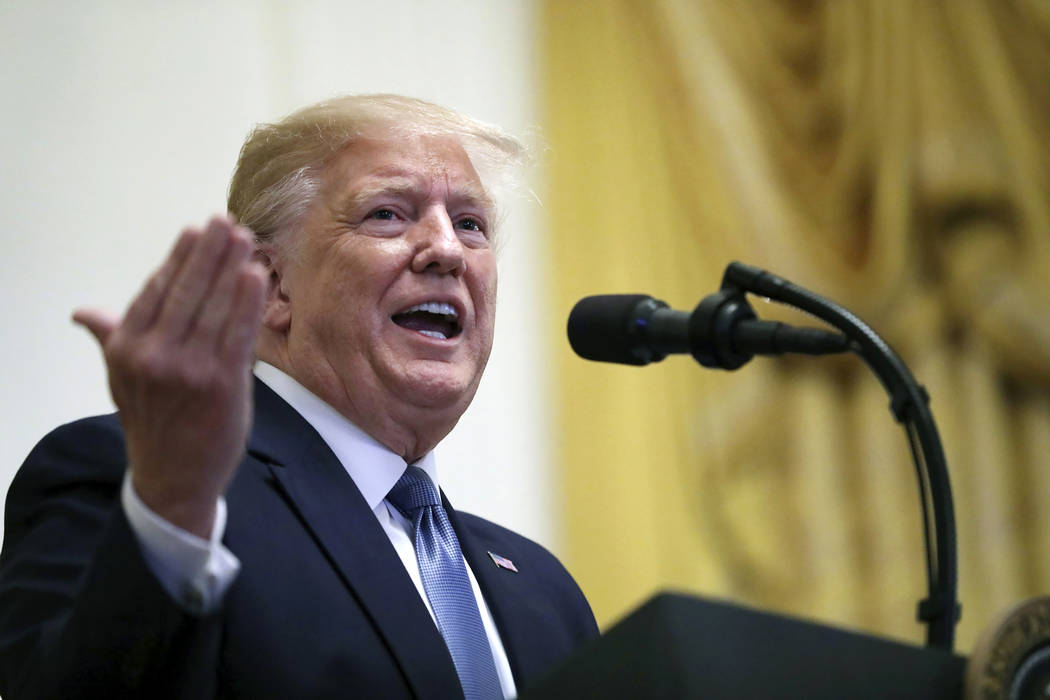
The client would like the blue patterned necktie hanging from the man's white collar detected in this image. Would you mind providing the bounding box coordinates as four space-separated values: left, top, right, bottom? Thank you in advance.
386 465 503 700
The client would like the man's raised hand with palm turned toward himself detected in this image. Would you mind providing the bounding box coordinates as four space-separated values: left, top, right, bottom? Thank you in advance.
74 216 267 537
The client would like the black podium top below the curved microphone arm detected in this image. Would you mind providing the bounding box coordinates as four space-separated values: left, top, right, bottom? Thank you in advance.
521 593 966 700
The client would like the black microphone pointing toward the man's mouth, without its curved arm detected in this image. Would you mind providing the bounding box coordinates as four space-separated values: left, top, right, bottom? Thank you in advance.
568 290 851 369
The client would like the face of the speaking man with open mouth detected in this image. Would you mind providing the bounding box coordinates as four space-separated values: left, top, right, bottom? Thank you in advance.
270 133 497 438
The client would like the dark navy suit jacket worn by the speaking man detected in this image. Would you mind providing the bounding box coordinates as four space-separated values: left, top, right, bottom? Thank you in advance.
0 382 597 700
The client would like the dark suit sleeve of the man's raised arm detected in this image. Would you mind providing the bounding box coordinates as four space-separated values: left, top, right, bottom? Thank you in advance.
0 416 221 700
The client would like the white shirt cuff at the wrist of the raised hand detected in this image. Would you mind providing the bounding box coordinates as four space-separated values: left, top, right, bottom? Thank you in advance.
121 470 240 614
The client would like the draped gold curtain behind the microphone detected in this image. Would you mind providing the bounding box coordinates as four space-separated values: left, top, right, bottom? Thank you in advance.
539 0 1050 650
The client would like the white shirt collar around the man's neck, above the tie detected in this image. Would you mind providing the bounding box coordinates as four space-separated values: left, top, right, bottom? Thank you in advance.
254 360 441 510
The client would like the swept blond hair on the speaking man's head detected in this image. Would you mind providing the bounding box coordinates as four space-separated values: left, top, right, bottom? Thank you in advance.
227 94 528 246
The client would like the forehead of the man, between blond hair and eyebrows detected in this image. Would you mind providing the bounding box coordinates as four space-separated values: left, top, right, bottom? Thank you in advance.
323 133 492 209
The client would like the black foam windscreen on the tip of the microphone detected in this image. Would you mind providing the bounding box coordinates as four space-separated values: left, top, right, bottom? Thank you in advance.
568 294 652 365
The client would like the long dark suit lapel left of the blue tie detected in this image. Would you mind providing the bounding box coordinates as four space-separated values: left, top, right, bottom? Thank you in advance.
249 381 462 698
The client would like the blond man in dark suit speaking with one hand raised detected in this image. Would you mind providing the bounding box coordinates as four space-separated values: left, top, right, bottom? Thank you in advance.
0 96 597 700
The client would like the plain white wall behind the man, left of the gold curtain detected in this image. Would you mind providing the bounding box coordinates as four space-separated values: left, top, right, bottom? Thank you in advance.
0 0 558 545
